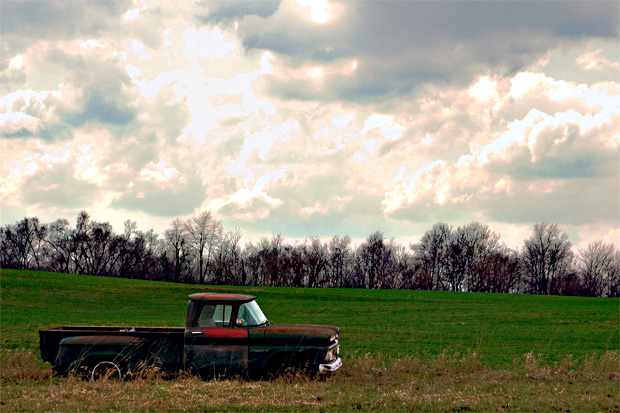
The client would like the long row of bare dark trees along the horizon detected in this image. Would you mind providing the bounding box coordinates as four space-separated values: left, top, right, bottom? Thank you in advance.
0 211 620 297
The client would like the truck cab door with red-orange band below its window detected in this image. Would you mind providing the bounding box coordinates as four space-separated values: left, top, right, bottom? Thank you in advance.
185 302 248 376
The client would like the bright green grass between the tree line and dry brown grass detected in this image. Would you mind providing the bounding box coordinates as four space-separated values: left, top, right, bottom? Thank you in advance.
0 270 620 367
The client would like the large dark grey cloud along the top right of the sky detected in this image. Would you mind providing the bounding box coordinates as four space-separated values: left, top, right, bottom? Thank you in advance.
229 1 619 101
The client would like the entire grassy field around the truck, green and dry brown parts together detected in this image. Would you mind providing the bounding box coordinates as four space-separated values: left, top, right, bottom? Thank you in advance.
0 270 620 411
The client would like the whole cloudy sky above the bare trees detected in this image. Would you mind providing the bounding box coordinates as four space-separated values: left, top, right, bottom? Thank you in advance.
0 0 620 248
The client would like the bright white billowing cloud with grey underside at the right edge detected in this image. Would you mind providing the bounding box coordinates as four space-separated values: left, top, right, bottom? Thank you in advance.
383 73 620 224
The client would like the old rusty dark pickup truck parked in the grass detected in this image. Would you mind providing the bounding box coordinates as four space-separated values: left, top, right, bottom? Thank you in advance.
39 293 342 380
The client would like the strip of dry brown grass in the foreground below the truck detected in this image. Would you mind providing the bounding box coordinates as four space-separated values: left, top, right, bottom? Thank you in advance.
0 350 620 411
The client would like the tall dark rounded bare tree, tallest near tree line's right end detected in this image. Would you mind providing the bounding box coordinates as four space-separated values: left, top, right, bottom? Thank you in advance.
522 222 572 295
